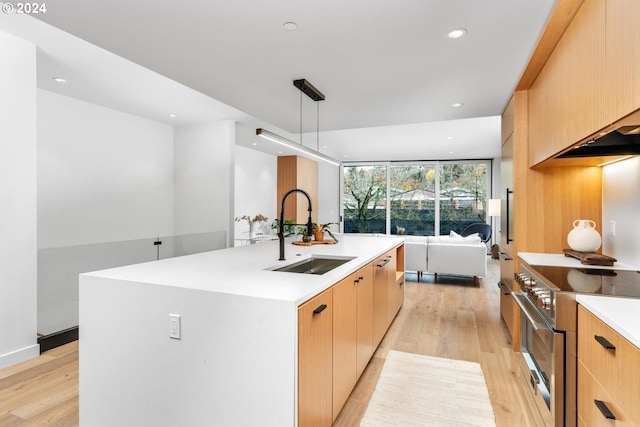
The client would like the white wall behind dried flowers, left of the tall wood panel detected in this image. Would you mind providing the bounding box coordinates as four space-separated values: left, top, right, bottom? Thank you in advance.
233 145 280 242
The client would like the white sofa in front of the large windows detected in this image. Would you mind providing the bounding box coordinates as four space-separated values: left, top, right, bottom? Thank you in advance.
404 233 487 286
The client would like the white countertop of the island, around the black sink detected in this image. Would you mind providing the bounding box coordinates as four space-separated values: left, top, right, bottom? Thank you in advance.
79 235 403 304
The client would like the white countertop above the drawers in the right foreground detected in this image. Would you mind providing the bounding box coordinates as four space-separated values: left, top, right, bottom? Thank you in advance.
576 294 640 348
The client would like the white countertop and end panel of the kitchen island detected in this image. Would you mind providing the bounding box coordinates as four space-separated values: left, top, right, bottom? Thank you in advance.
80 236 404 427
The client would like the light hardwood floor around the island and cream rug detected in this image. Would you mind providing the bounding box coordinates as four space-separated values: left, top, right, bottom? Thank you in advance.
0 260 536 427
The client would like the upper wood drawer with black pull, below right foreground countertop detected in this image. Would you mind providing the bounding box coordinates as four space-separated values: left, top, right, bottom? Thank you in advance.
578 306 640 420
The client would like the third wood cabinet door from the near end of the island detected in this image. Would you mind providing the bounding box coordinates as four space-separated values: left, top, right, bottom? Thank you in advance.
356 264 375 378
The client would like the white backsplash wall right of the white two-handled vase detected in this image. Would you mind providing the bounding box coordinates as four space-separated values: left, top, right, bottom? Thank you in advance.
602 157 640 267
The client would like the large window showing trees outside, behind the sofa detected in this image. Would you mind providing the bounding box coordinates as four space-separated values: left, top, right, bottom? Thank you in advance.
342 160 491 236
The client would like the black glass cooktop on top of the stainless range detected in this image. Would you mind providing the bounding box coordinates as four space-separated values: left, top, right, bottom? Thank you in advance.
530 265 640 298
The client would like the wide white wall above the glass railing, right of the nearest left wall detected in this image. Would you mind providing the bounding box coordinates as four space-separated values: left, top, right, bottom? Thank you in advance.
38 90 173 248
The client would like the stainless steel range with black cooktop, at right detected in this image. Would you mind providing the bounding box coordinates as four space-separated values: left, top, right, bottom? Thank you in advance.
513 262 640 427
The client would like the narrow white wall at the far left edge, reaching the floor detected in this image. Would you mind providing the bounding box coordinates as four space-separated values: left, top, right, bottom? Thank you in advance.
0 32 39 368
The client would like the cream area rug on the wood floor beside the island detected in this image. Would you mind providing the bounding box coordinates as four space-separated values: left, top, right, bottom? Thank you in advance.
360 351 495 427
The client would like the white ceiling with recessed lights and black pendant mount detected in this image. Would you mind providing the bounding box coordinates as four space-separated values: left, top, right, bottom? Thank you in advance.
0 0 555 159
